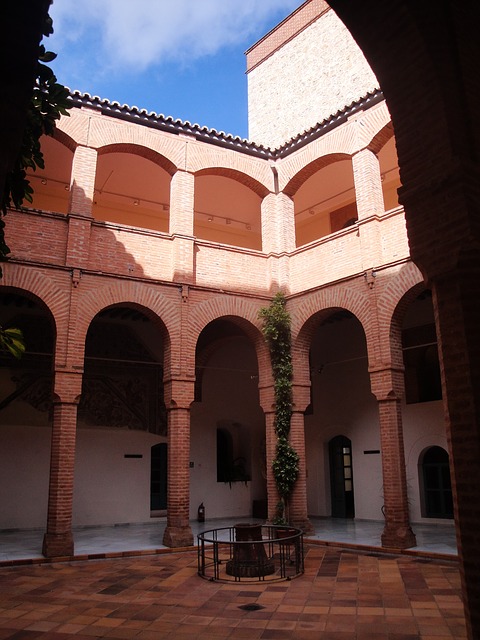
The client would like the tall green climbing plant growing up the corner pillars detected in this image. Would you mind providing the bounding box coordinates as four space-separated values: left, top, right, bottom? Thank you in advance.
259 292 299 524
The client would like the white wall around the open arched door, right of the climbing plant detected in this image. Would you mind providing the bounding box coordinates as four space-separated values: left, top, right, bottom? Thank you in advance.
305 321 383 520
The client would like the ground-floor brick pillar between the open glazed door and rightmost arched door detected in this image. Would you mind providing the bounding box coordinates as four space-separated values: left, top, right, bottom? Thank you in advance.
370 368 416 549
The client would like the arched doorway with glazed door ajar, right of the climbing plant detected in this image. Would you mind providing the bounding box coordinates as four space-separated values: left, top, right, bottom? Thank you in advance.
328 436 355 518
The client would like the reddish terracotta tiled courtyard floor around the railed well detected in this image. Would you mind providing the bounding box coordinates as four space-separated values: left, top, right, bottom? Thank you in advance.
0 545 466 640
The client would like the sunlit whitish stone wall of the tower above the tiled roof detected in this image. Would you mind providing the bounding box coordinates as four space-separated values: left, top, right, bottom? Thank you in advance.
247 10 378 147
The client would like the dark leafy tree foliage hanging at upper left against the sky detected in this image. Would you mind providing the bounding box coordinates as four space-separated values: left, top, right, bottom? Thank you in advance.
0 15 71 277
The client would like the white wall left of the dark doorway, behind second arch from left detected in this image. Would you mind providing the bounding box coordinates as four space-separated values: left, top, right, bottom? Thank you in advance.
73 429 165 526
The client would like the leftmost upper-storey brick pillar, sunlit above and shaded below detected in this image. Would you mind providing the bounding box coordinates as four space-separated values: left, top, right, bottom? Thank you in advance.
65 146 97 269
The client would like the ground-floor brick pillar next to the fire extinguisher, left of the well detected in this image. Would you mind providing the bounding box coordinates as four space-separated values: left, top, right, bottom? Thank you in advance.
163 380 194 547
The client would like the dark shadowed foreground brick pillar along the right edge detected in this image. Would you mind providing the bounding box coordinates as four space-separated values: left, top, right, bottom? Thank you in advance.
401 157 480 639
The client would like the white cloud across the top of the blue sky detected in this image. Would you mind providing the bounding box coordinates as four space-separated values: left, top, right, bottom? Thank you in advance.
51 0 301 71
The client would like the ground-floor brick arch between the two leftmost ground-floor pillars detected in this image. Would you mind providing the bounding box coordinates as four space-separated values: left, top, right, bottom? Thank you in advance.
76 282 180 374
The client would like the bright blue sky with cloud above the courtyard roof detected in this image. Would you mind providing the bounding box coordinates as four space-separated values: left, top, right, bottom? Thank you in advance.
44 0 303 138
